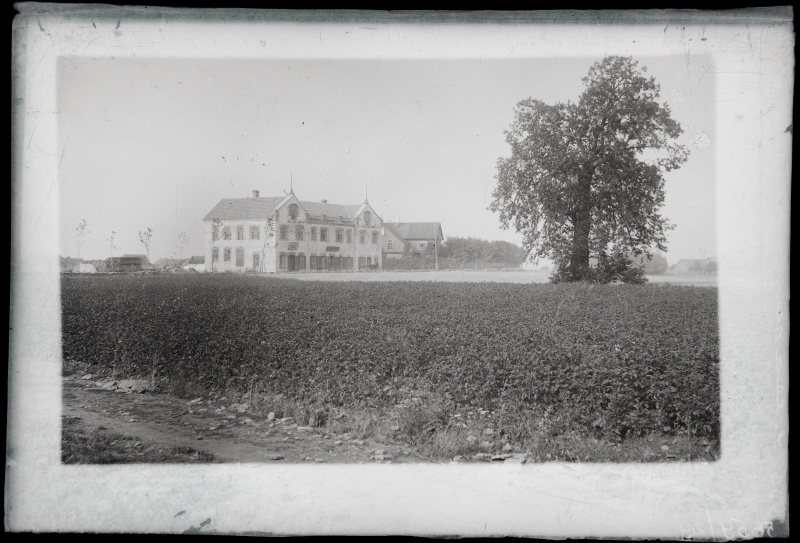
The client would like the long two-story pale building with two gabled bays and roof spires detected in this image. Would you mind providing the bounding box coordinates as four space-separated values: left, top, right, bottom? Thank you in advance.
203 190 382 272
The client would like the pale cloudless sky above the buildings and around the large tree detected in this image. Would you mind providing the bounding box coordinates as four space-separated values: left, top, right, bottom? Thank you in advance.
57 55 716 263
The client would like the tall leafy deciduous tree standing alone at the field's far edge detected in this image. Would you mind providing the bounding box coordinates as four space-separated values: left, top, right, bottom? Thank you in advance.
490 56 688 281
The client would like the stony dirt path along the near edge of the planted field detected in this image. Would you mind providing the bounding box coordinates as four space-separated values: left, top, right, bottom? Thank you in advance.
62 375 435 463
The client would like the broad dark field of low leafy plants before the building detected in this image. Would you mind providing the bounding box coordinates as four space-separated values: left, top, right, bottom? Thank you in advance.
62 274 720 459
